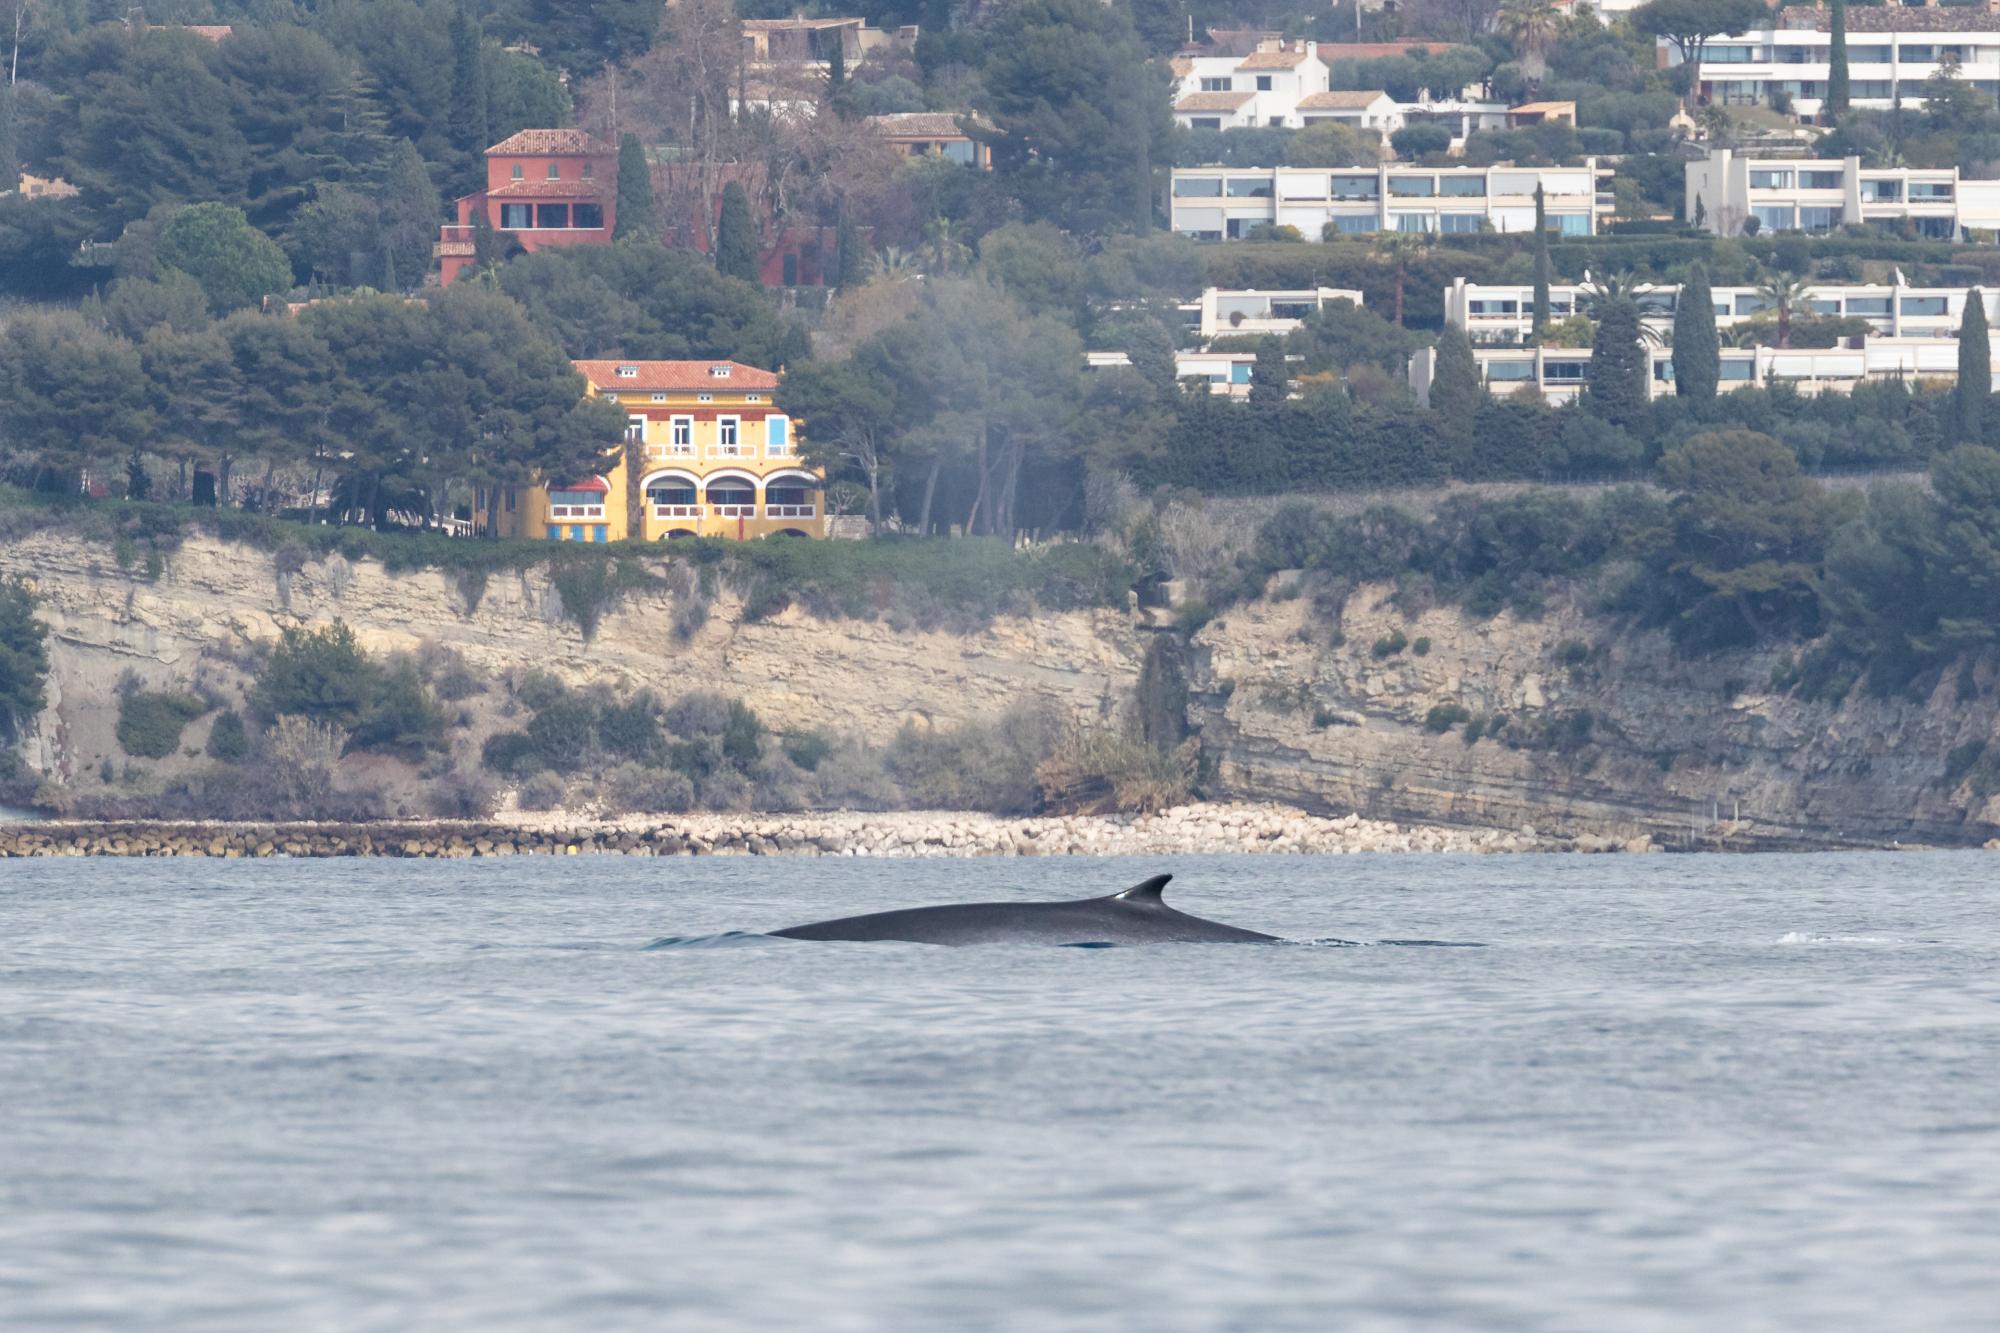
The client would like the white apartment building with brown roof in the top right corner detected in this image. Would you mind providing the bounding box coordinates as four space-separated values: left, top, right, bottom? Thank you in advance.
1660 4 2000 120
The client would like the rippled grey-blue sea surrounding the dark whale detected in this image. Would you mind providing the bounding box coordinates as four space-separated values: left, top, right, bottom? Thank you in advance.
0 853 2000 1333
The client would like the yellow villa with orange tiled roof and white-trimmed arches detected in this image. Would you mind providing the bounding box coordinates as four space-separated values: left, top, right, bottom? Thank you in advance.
474 360 826 542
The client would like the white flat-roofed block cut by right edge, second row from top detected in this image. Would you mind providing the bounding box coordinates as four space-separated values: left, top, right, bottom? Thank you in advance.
1686 150 2000 240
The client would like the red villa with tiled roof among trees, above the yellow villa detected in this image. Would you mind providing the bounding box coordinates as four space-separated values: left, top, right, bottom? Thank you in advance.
438 130 618 282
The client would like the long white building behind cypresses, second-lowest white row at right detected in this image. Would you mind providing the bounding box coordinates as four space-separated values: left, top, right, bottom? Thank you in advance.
1444 274 2000 346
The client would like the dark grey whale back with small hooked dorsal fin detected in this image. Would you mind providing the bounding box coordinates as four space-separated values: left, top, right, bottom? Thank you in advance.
772 875 1278 945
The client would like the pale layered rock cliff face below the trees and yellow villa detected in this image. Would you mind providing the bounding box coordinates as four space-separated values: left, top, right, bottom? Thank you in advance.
0 534 2000 847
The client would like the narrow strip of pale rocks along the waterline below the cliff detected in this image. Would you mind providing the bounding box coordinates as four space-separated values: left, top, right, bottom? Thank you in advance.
0 805 1632 859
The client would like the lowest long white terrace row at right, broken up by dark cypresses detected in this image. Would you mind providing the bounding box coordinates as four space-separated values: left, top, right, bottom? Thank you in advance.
1410 338 2000 406
